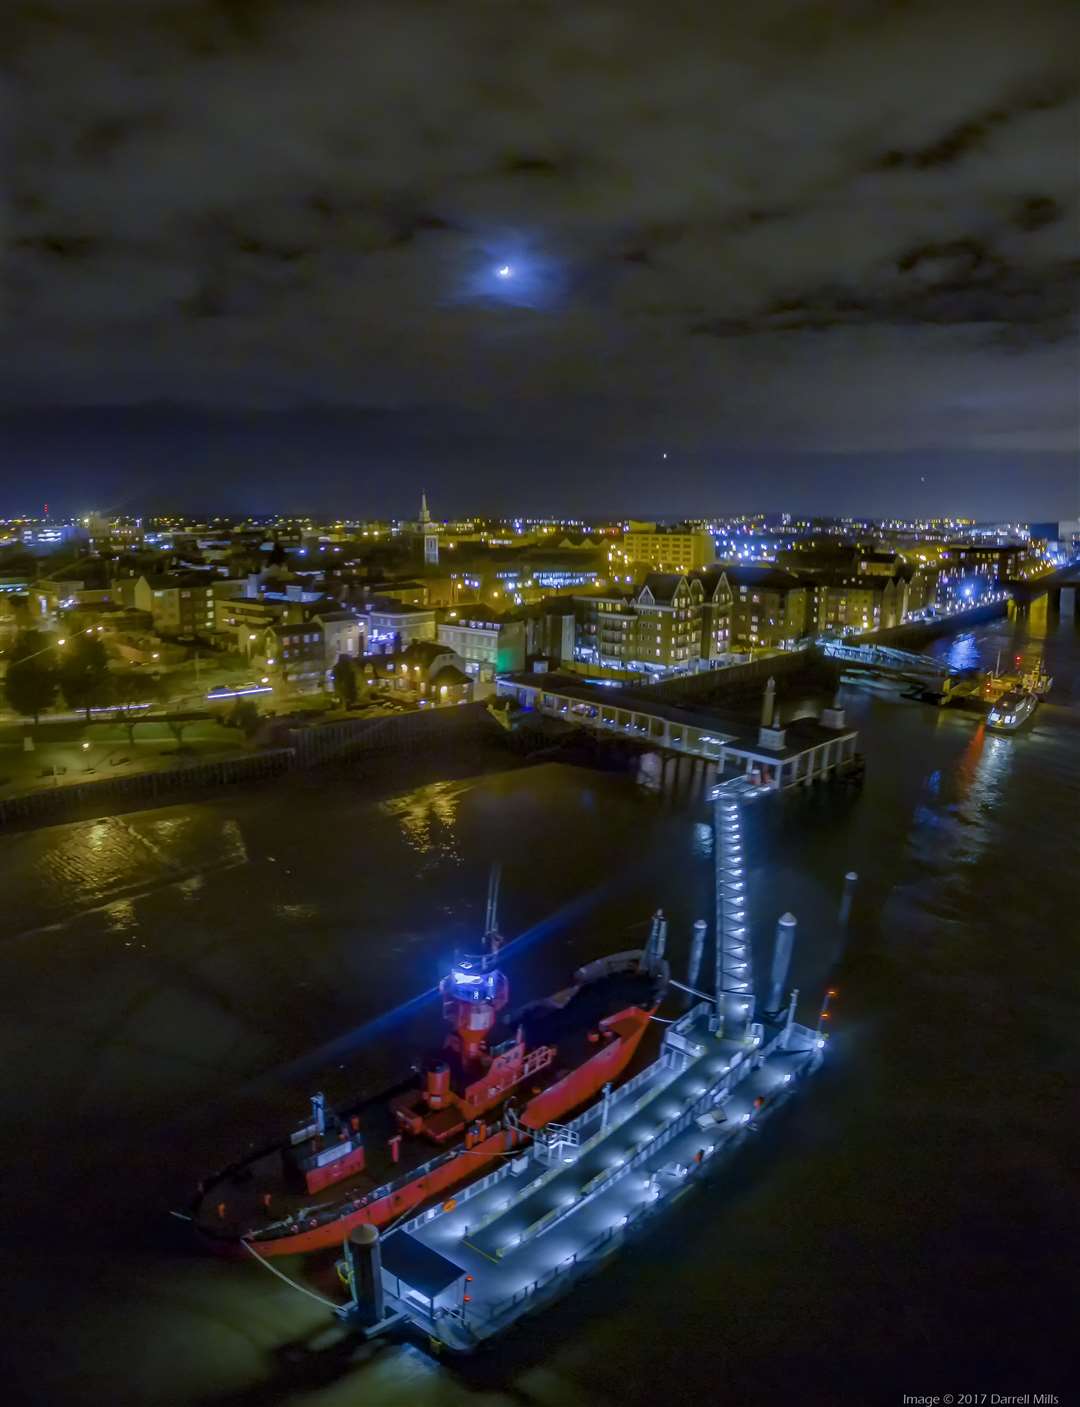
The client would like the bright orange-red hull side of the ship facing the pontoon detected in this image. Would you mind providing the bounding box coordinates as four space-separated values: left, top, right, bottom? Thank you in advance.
210 1007 655 1256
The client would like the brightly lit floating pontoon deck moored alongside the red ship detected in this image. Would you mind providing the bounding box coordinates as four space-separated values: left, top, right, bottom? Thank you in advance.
376 1003 824 1349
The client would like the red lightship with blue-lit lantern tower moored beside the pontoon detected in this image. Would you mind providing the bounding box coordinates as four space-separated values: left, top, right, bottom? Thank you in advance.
193 915 668 1256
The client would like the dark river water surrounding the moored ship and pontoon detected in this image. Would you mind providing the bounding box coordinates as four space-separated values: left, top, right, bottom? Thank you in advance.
0 604 1080 1407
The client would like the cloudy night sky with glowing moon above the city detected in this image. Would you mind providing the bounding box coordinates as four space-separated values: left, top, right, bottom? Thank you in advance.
0 0 1080 518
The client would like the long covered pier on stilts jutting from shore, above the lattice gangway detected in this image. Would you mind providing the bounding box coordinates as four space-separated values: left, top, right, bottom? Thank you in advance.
496 673 858 789
